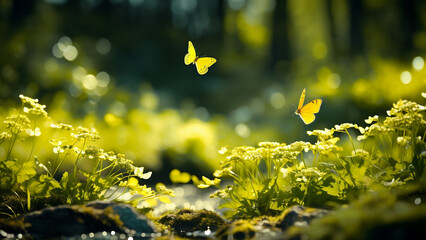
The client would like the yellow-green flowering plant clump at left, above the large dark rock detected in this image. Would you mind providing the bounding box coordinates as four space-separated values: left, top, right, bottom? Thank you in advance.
0 95 174 216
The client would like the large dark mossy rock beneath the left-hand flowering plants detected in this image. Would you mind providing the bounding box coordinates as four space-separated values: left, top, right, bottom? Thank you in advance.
0 201 156 238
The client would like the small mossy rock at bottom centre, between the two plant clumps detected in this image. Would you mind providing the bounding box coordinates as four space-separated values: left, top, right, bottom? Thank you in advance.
158 209 225 236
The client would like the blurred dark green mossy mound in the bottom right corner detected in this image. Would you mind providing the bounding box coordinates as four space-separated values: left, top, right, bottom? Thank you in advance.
286 184 426 240
